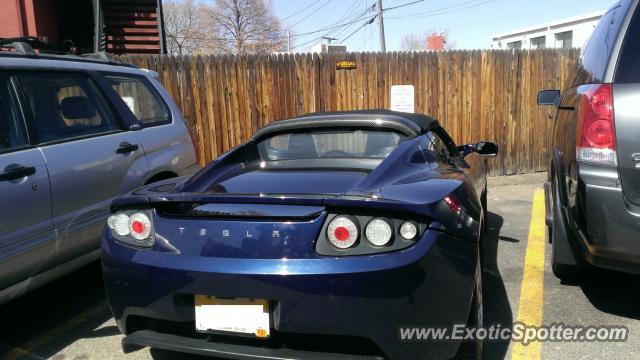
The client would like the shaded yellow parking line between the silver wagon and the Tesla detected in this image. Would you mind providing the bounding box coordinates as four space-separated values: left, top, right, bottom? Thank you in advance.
0 302 107 360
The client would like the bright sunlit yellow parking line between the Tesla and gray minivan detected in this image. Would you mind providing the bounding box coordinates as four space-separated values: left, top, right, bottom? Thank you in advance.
511 189 546 360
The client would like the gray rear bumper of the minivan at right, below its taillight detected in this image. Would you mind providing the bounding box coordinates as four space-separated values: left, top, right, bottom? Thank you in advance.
576 165 640 274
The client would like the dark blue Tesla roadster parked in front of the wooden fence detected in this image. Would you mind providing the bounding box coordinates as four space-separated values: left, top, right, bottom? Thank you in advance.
102 110 497 359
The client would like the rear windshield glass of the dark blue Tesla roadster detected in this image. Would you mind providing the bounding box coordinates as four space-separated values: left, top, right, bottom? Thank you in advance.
258 130 405 161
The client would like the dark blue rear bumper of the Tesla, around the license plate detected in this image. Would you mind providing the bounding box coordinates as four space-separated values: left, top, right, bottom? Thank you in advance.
102 231 477 359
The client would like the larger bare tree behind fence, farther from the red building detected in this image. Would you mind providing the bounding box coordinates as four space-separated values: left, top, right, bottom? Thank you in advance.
214 0 286 54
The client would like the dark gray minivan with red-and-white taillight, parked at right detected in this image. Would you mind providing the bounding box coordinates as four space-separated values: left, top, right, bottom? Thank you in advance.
538 0 640 279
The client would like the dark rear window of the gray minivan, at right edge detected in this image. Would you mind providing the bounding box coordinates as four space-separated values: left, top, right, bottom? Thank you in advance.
615 3 640 82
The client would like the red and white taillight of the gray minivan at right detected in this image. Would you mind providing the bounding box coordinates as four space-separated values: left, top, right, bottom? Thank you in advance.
576 84 617 166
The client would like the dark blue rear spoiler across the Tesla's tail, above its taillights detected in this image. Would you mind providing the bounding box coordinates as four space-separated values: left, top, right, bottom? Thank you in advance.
111 178 482 241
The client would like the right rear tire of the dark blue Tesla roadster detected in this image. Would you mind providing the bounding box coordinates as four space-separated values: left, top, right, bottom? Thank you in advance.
454 249 484 360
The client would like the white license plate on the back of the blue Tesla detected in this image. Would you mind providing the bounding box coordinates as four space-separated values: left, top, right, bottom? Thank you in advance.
195 295 270 339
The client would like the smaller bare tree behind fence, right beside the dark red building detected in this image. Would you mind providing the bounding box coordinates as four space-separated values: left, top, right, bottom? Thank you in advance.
163 0 223 55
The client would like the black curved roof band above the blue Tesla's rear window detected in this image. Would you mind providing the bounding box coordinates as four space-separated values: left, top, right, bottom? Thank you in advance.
251 109 438 141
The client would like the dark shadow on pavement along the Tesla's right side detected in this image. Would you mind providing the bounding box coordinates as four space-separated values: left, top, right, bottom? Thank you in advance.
482 212 518 359
